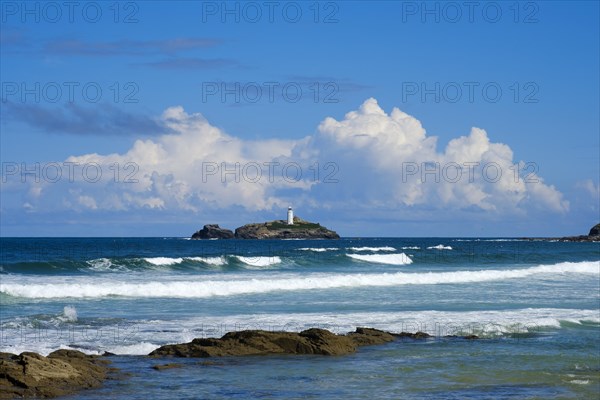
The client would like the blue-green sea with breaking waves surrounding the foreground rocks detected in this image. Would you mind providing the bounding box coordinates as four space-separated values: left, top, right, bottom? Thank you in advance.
0 238 600 399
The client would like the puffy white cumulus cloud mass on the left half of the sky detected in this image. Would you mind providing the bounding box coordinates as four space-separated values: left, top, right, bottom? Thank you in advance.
59 107 305 211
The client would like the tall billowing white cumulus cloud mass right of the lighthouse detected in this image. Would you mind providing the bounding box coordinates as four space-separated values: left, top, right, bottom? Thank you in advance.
319 98 569 212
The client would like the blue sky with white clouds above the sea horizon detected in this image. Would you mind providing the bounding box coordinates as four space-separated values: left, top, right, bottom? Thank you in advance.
0 1 600 237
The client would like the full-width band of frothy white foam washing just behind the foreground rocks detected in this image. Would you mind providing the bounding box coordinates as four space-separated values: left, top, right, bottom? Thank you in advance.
0 308 600 354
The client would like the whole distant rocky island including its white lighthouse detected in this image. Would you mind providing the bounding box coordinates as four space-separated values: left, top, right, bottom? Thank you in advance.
192 207 340 239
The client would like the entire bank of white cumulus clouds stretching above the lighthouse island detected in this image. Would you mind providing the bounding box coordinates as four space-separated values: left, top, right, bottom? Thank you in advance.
11 98 569 214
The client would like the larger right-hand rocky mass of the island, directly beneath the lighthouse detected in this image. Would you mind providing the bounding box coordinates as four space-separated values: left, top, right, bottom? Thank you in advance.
235 217 340 239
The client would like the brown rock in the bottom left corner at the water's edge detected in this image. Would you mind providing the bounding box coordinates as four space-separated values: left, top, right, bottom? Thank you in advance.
0 350 109 399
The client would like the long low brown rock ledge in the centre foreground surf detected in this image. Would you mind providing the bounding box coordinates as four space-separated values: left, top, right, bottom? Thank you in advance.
150 328 394 357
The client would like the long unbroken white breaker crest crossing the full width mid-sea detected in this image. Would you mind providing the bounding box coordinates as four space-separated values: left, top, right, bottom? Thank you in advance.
0 255 600 298
